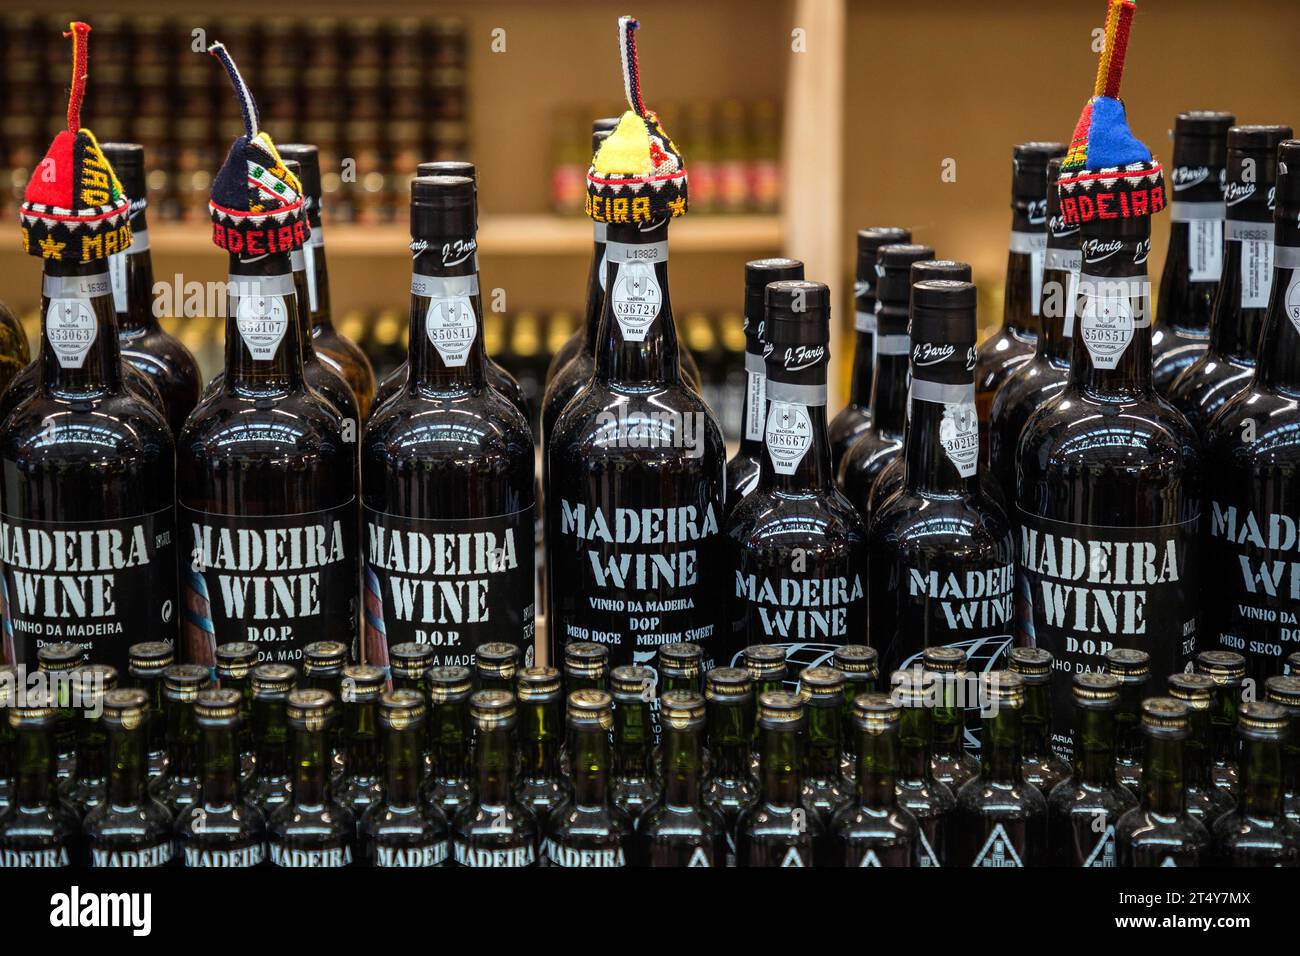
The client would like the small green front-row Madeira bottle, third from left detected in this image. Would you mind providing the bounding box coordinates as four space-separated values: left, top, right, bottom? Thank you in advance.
176 687 267 869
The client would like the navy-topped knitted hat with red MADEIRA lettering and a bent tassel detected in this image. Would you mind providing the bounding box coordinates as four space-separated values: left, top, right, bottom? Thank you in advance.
208 43 309 256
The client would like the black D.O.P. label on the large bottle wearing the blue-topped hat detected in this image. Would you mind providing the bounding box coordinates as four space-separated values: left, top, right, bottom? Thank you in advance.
1018 509 1200 757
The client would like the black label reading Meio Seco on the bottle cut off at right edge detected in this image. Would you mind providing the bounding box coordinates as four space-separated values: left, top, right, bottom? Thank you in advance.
1208 496 1300 680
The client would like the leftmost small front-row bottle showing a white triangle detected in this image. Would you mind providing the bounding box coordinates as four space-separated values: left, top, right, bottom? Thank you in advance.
636 691 727 866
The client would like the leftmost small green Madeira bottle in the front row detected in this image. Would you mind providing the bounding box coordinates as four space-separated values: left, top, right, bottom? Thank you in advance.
0 691 81 868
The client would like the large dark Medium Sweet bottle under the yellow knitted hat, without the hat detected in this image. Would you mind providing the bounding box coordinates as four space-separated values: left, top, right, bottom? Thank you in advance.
546 220 725 666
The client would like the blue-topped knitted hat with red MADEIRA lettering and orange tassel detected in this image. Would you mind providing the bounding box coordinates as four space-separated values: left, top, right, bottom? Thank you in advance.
1057 0 1166 225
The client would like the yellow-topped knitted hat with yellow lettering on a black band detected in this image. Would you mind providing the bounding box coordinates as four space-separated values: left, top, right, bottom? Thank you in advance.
586 17 686 222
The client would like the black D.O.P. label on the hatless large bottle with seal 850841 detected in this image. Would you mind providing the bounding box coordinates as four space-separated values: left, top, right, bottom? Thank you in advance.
364 506 537 666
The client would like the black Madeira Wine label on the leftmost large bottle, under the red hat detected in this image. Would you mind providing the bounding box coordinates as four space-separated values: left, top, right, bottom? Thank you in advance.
0 507 176 674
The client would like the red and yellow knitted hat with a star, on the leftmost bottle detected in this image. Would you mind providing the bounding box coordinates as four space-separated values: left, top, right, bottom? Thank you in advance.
18 21 131 263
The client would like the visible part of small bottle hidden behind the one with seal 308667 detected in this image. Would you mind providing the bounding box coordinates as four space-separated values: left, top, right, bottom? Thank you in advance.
723 259 803 522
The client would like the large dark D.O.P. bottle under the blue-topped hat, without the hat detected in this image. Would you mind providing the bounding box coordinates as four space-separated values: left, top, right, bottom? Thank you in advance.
1017 210 1201 757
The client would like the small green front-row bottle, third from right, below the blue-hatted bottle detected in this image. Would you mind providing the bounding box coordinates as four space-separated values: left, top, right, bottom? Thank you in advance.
1045 671 1138 868
